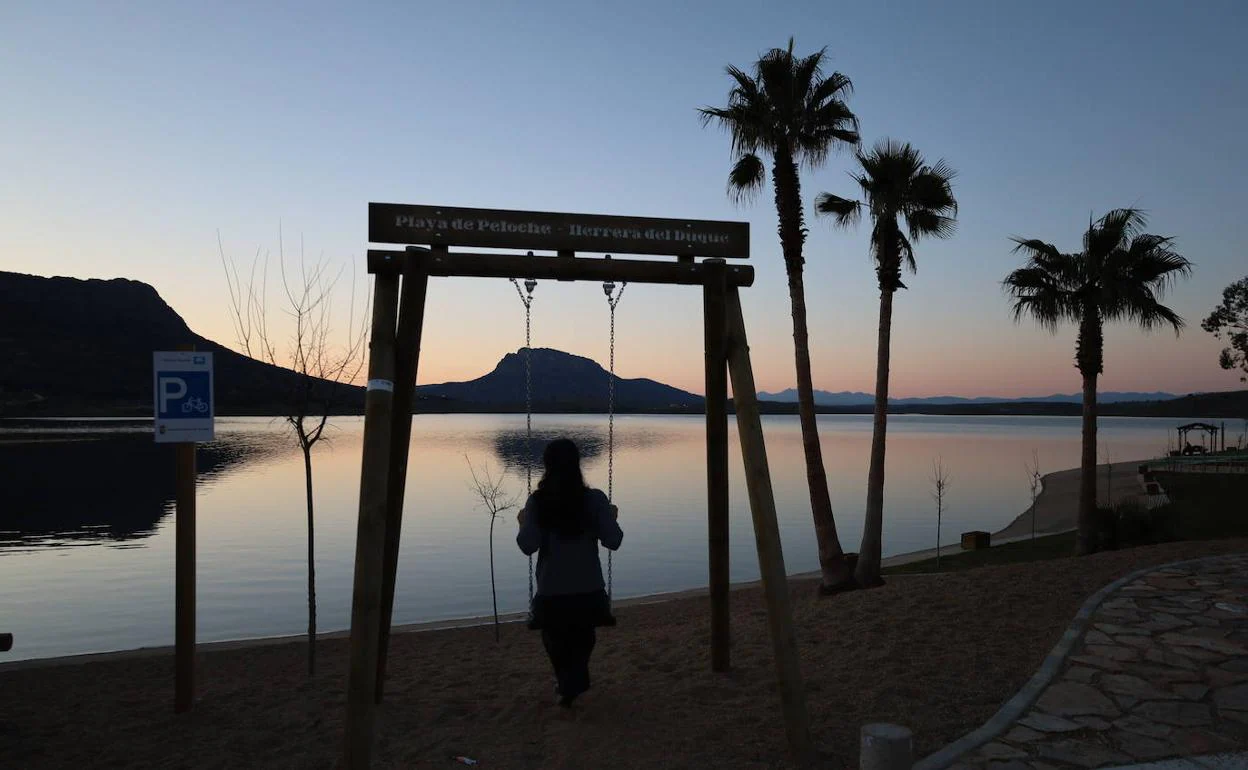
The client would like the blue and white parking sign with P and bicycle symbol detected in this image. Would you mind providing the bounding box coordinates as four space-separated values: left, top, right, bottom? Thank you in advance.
152 351 215 443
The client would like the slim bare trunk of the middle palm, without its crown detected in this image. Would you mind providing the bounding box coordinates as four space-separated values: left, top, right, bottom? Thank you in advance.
854 288 895 588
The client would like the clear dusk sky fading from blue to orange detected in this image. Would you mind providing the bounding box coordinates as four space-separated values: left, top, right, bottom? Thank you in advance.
0 0 1248 397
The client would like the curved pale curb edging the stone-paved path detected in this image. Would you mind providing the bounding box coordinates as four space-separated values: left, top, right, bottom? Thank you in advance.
912 554 1243 770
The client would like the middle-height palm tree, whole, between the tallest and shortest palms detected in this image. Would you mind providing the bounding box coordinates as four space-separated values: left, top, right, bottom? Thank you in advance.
815 140 957 588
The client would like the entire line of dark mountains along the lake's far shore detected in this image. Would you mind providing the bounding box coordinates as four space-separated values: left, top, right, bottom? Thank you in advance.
0 272 1248 418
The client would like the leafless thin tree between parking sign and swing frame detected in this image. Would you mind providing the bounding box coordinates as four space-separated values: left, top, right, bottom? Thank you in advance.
217 230 369 676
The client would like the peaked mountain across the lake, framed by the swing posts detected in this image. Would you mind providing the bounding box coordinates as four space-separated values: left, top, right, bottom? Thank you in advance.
416 348 703 412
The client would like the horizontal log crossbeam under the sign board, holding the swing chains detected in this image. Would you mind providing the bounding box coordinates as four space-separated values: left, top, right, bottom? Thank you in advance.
368 248 754 286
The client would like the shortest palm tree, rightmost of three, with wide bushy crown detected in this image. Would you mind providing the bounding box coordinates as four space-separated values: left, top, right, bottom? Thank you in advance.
1005 208 1192 555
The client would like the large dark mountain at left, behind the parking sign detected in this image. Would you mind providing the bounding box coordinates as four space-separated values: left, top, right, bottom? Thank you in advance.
0 272 363 417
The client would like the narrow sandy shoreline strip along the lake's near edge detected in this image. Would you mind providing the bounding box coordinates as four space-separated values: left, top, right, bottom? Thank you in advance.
0 461 1147 673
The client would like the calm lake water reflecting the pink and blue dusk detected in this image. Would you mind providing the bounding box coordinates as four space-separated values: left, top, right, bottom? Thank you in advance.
0 416 1231 660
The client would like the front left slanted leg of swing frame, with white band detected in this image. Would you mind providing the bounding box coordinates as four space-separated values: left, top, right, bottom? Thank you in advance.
344 271 398 770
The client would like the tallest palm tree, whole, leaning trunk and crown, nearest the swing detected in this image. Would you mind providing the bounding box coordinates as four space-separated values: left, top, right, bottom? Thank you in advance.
699 37 859 592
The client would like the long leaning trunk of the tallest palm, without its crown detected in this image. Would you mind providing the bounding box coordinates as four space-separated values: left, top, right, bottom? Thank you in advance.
773 154 850 593
